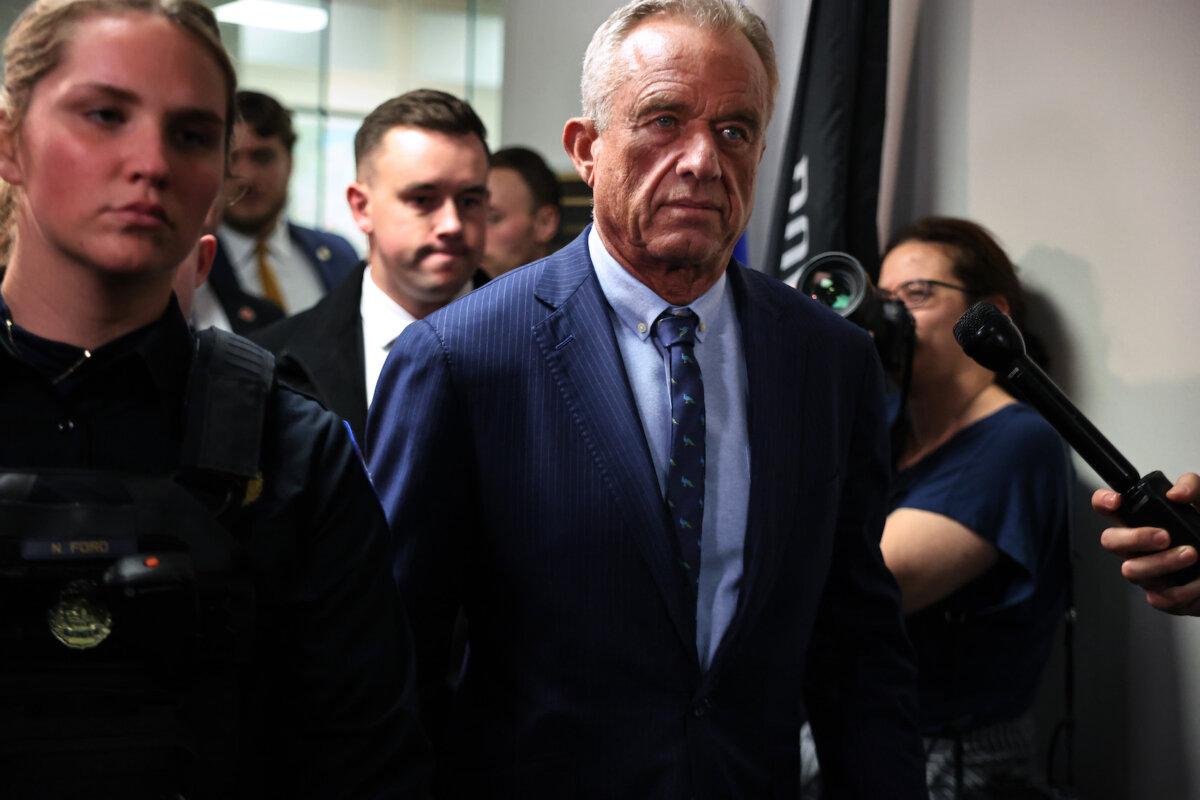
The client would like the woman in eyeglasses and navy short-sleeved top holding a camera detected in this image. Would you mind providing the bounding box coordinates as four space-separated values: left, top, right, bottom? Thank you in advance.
878 217 1070 799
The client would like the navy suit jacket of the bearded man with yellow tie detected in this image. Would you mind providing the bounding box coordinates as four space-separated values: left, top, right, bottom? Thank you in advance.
209 222 359 336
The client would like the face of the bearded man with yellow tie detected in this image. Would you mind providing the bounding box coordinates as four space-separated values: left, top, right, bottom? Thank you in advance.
224 122 292 235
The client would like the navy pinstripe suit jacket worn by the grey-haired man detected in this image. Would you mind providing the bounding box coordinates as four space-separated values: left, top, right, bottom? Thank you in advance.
367 227 925 800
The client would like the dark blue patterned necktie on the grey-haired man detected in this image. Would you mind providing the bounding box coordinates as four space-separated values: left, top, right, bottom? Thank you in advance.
654 308 704 590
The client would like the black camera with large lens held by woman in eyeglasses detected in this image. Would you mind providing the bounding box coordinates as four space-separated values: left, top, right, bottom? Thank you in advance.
796 252 914 375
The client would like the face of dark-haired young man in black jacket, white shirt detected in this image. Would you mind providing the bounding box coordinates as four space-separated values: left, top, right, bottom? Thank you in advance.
347 127 487 315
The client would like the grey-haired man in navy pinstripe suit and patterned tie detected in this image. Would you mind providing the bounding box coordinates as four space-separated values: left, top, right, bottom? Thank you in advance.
367 0 925 800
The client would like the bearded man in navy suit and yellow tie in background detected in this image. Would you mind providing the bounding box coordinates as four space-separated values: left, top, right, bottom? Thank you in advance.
198 91 359 333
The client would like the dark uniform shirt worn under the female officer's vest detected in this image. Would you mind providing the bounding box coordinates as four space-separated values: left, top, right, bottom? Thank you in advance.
0 299 427 799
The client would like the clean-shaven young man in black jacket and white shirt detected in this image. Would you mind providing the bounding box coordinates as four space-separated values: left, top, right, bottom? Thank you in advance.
254 89 488 441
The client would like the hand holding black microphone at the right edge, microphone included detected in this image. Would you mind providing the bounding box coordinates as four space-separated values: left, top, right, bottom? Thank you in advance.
954 302 1200 613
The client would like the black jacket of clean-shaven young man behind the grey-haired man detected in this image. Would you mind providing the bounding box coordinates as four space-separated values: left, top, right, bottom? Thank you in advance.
251 264 367 443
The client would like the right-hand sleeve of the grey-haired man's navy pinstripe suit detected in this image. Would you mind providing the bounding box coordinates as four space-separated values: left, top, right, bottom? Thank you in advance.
805 338 926 800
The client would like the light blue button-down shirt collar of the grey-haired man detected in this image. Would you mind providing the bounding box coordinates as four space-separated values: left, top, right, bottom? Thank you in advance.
588 225 727 342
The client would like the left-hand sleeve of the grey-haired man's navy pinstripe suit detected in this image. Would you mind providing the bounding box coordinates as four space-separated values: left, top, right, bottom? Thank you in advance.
367 321 478 742
